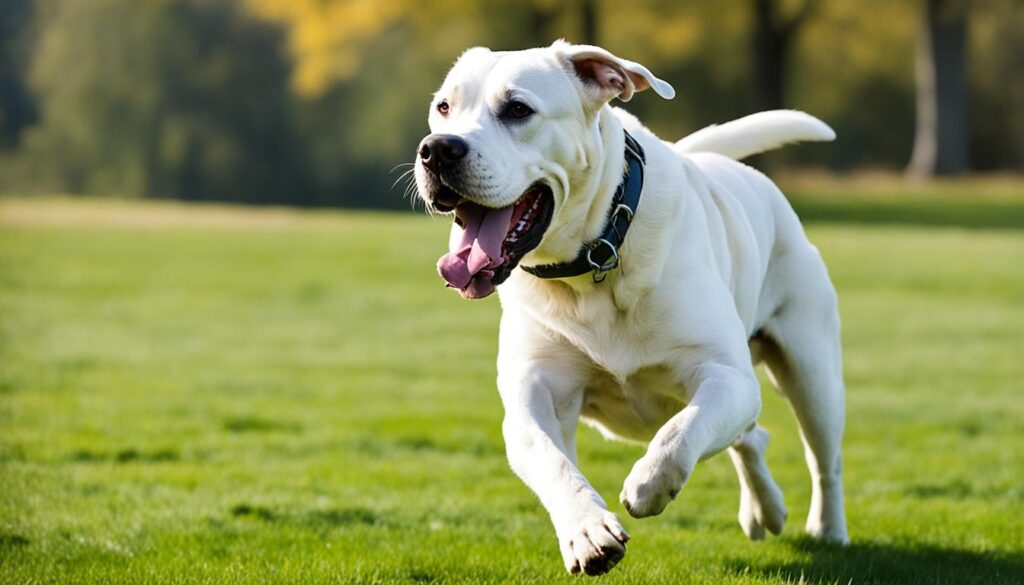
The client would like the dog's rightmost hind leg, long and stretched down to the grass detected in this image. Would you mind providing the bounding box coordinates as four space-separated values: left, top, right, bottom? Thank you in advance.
764 286 849 543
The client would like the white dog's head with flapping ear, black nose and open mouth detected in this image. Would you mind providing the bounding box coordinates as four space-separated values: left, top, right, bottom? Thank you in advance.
416 41 675 298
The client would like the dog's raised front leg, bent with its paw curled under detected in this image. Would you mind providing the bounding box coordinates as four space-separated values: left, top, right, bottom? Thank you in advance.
618 360 761 518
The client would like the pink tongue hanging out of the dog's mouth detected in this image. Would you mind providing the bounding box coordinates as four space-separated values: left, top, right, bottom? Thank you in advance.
437 203 515 298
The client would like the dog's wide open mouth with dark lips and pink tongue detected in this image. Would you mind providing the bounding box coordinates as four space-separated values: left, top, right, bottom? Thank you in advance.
437 184 554 298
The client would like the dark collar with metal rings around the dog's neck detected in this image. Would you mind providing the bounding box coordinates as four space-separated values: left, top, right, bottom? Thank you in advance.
522 130 647 283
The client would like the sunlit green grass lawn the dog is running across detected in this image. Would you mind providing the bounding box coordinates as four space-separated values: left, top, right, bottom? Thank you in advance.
0 201 1024 584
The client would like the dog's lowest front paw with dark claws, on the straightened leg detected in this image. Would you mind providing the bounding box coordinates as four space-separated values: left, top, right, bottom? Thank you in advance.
559 510 630 575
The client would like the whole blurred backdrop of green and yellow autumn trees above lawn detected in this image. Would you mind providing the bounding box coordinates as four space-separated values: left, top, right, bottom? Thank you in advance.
0 0 1024 208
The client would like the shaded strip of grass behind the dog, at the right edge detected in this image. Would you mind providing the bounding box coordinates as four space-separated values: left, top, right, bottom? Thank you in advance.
790 195 1024 229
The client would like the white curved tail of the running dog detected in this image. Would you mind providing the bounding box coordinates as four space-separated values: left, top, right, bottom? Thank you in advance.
675 110 836 161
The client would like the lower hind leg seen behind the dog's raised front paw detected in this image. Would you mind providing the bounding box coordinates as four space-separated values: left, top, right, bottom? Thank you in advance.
729 426 786 540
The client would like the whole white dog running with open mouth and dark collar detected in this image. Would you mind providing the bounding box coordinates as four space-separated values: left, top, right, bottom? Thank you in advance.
416 41 847 575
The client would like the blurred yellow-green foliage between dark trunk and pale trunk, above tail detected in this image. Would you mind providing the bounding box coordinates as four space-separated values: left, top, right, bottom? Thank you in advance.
786 0 918 170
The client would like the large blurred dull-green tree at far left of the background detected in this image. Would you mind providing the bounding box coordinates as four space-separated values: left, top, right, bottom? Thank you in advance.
27 0 306 202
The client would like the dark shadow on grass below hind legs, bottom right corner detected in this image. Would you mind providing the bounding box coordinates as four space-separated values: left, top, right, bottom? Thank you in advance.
735 538 1024 585
